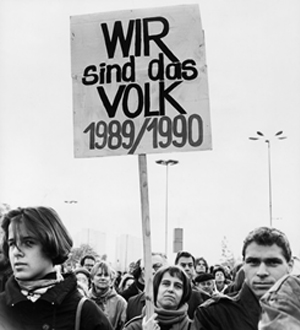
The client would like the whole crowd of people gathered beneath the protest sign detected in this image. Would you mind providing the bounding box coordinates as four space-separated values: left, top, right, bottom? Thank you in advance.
0 206 300 330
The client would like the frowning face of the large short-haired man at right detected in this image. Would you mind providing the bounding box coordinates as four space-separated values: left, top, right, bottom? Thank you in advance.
244 242 293 298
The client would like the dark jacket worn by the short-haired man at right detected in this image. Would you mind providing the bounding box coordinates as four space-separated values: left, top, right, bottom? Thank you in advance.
192 283 261 330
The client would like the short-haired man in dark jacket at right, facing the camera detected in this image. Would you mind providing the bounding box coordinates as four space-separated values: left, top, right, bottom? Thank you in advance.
193 227 293 330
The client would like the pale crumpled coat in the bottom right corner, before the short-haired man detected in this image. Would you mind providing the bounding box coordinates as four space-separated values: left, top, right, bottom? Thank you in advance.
259 275 300 330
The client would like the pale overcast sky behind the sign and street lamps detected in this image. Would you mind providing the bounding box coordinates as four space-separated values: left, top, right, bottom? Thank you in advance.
0 0 300 263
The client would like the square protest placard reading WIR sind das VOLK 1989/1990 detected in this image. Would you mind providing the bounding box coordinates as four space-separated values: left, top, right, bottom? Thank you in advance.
71 6 211 157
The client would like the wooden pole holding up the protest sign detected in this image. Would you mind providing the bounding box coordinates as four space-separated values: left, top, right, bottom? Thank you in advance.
139 154 154 319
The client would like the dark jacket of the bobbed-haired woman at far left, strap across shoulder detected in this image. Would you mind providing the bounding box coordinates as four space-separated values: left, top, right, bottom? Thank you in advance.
0 274 112 330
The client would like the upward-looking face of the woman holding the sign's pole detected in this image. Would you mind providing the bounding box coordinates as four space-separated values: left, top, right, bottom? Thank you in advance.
156 271 183 310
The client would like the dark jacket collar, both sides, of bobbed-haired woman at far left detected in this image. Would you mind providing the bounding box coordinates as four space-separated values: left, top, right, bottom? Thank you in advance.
5 273 77 306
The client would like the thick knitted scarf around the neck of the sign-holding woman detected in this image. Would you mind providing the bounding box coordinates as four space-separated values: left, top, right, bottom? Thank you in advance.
154 303 191 330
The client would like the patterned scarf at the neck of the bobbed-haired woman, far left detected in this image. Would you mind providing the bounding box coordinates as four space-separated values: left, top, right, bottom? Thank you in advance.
16 272 64 302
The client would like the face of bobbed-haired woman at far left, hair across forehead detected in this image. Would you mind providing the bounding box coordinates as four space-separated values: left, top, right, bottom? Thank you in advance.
8 223 54 280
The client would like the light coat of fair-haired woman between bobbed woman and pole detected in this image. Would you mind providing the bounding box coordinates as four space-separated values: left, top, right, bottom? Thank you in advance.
89 288 127 330
